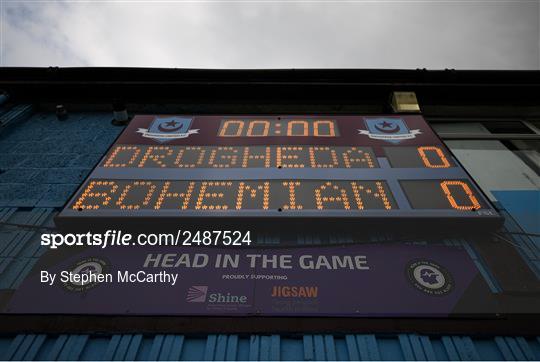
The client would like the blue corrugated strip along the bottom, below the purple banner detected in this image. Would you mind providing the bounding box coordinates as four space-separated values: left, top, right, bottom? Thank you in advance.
0 334 540 361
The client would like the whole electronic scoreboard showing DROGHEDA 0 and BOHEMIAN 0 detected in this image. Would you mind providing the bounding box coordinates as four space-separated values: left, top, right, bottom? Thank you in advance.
56 115 501 232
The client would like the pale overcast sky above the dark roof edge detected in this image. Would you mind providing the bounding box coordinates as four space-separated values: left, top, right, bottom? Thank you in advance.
0 0 540 69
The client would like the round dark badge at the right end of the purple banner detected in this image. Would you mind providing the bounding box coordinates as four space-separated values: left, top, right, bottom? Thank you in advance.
406 260 454 296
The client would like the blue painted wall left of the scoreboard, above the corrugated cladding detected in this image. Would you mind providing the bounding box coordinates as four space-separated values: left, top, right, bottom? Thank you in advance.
0 109 122 207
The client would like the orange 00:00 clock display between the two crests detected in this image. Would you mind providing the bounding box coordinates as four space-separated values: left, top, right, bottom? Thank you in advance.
218 119 339 137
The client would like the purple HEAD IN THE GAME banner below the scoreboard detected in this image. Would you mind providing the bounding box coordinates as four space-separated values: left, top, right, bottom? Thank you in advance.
2 244 498 317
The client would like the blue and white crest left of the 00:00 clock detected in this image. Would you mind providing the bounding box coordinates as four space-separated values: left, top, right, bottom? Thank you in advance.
137 117 199 143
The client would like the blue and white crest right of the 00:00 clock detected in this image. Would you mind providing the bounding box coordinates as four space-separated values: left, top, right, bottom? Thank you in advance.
358 117 422 143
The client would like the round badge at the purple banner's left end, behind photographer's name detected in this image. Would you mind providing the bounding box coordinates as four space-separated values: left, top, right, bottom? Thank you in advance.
63 258 108 292
